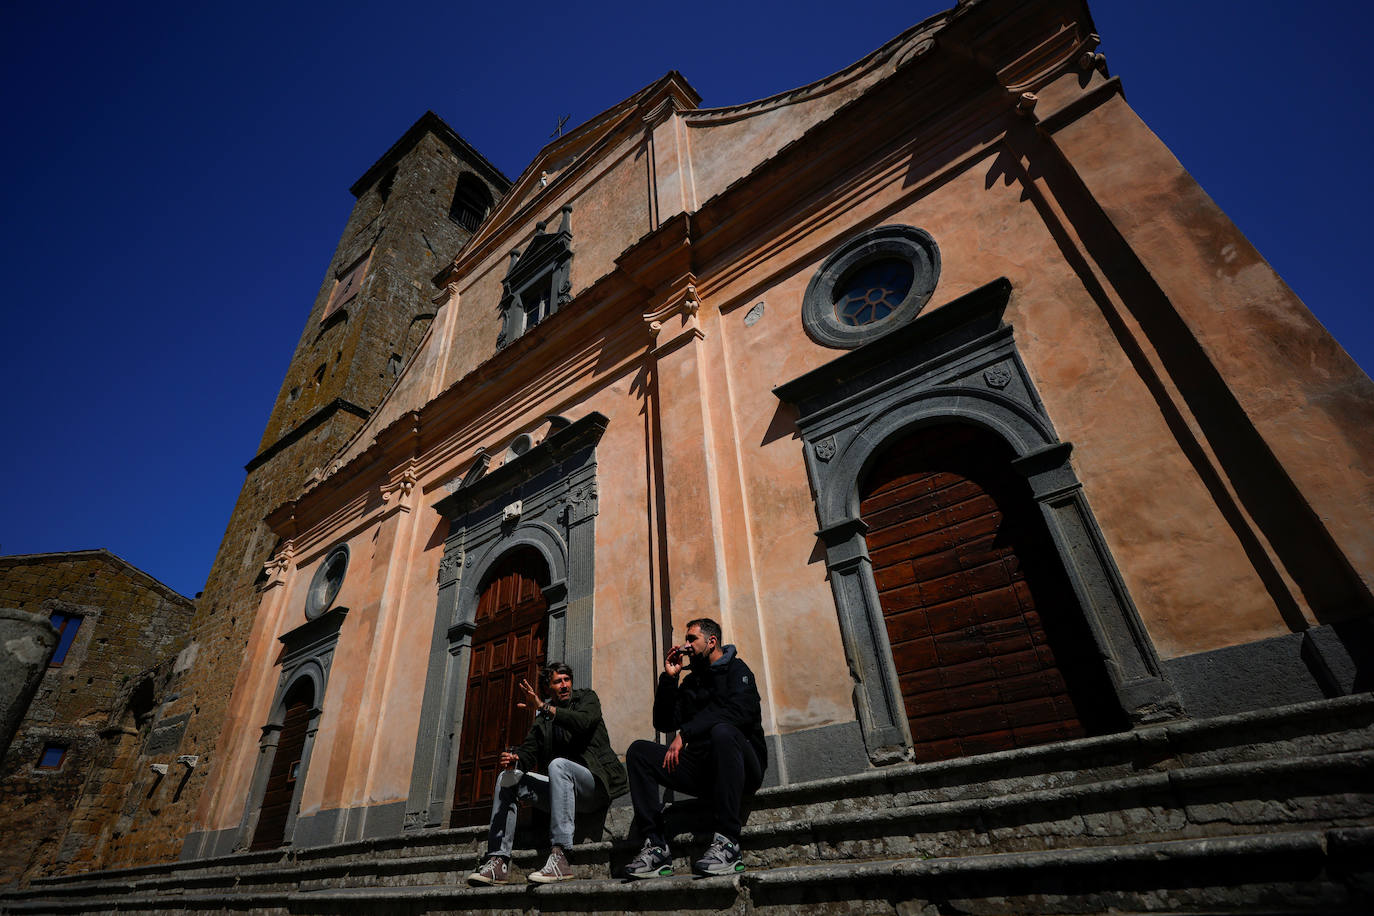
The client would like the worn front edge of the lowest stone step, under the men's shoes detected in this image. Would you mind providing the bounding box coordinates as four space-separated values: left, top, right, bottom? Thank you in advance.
7 827 1374 912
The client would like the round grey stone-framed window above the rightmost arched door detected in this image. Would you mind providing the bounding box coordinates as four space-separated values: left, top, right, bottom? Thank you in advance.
801 225 940 349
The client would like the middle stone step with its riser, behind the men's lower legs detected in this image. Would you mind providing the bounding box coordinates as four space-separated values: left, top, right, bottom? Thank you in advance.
16 751 1374 894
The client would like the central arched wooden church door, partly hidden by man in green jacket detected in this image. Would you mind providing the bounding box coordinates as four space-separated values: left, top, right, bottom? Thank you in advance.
449 549 548 827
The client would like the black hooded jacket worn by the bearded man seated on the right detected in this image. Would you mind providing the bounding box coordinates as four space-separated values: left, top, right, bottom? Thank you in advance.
654 645 768 768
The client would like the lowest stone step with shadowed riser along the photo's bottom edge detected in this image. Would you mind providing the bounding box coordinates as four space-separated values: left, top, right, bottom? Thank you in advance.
4 828 1374 916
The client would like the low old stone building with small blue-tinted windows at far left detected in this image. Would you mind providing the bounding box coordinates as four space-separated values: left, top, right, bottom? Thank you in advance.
0 549 191 883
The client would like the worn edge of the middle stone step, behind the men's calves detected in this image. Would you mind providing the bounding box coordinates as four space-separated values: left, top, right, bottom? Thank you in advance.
13 751 1374 901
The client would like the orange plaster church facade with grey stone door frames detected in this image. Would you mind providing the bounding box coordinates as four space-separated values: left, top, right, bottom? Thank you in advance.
166 0 1374 858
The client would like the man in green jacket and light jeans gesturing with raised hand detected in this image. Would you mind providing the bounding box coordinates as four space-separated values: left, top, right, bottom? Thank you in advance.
467 663 629 884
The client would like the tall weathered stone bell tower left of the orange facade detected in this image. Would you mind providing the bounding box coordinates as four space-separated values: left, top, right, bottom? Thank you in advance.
100 111 510 868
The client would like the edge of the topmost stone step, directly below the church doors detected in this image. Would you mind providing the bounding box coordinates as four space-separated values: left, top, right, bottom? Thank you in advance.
21 694 1374 886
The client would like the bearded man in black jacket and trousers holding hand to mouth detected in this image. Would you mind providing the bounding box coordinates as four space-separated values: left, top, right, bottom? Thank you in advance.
625 617 768 878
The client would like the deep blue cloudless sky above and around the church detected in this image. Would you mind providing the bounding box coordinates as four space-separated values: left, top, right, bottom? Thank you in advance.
0 0 1374 595
